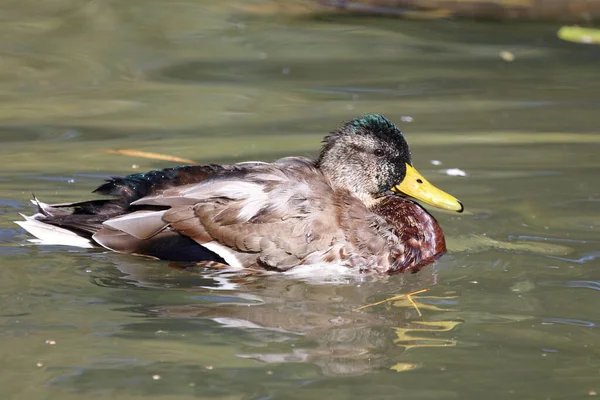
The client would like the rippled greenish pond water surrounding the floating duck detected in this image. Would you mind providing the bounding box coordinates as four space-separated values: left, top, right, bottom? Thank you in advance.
0 0 600 400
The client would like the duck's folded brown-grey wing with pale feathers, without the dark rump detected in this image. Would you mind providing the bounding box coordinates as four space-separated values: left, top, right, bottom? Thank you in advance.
94 164 343 270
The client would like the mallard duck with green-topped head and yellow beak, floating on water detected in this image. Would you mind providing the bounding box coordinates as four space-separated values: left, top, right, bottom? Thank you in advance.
17 114 463 274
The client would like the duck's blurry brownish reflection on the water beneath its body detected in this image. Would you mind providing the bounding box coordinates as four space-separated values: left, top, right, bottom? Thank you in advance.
102 254 450 376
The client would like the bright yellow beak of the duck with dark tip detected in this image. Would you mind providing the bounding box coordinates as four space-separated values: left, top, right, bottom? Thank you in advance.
392 164 465 212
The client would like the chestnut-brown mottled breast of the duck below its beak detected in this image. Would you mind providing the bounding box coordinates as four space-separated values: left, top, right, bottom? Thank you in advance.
371 195 446 274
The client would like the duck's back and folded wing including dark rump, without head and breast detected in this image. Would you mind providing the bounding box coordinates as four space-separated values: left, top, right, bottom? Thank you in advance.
25 158 356 270
